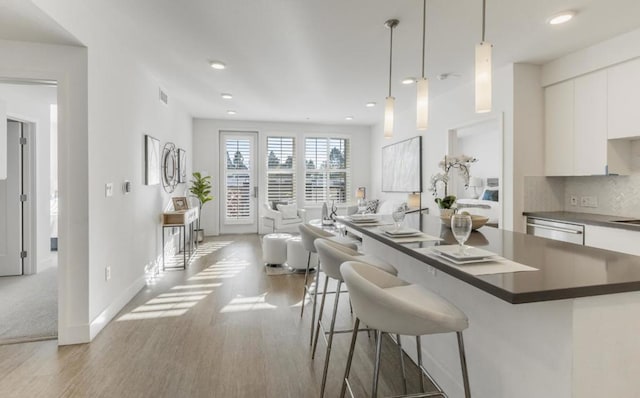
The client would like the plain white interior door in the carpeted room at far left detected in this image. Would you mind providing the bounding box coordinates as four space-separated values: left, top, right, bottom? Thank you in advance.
0 121 23 276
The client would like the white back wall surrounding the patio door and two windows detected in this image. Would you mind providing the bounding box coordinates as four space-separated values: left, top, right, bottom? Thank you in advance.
193 119 371 235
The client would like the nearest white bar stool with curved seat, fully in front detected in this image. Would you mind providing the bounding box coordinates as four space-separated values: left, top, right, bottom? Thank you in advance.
340 261 471 398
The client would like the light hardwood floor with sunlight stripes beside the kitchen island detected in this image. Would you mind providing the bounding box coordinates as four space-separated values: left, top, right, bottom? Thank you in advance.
0 235 432 398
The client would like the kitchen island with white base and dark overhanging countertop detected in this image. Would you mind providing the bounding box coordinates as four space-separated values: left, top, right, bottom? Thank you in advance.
342 215 640 398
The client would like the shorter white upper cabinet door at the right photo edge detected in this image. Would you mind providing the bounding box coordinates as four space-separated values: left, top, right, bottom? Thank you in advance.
607 59 640 138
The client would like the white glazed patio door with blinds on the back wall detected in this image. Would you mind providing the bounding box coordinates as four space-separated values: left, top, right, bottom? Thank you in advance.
220 131 258 234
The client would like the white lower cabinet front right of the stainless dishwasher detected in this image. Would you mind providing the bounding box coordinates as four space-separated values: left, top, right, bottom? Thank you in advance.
584 225 640 256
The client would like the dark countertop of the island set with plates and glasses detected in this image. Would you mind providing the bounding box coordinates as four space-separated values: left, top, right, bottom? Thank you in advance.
341 214 640 304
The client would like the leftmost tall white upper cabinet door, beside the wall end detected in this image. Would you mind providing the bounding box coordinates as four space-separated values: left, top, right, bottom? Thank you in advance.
544 80 574 176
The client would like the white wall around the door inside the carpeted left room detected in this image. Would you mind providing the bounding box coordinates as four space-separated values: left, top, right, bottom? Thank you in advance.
0 84 57 270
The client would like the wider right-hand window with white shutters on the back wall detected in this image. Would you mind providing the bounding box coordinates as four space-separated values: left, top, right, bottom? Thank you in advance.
304 138 351 203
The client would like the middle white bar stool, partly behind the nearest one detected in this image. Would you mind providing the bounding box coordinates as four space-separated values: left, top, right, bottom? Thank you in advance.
311 239 404 398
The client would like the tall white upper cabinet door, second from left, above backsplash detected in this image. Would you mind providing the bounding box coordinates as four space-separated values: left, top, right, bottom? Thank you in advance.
573 71 607 176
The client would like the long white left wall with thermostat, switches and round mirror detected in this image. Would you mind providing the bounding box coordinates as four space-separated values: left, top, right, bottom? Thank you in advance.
21 0 192 343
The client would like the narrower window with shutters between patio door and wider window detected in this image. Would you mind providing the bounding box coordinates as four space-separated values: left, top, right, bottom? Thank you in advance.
267 137 296 202
